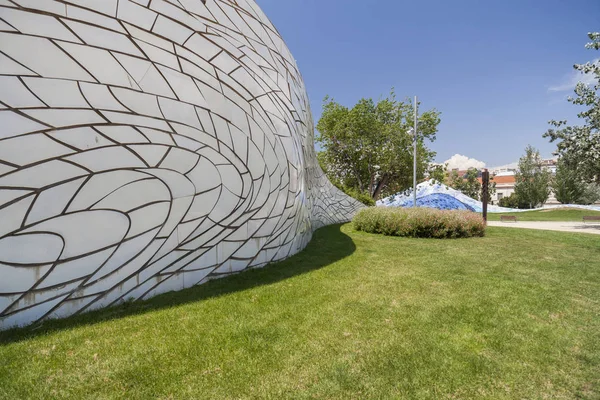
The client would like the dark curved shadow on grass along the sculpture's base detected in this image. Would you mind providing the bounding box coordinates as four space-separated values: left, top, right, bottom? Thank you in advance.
0 225 356 346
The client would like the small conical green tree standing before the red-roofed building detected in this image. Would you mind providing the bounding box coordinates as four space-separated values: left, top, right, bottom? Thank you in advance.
515 145 552 208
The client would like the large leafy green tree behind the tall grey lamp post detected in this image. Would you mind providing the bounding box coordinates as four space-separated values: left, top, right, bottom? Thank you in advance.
317 90 440 200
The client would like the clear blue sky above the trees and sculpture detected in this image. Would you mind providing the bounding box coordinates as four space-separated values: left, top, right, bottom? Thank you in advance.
257 0 600 167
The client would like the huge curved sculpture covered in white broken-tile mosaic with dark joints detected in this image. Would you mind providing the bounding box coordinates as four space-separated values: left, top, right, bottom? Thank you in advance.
0 0 360 329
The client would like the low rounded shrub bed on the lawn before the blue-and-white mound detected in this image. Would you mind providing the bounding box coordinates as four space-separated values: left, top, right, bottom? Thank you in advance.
352 207 485 239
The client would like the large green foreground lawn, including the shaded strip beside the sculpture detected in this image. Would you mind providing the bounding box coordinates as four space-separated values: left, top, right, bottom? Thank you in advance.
0 225 600 399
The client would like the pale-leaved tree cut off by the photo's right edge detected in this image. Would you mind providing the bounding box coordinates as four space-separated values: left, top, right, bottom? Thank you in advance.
544 32 600 184
